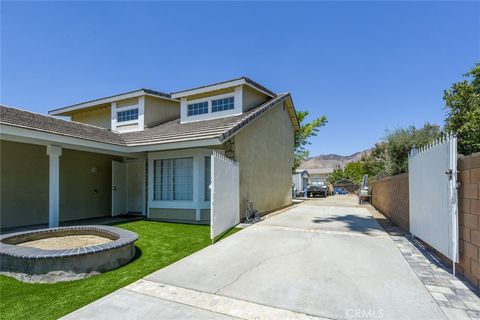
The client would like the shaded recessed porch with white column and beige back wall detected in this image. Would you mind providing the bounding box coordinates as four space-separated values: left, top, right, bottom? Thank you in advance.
0 139 146 232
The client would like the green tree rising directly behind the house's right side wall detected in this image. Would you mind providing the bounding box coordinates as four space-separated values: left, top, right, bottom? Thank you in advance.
293 111 327 170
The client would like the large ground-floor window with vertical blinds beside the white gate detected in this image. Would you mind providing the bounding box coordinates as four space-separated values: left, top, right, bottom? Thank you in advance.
153 158 193 200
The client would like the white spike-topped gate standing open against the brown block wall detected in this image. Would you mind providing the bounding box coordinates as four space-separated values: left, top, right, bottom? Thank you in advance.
408 135 458 272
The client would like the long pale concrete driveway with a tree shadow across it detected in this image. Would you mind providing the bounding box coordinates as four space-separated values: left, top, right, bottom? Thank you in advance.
64 198 445 320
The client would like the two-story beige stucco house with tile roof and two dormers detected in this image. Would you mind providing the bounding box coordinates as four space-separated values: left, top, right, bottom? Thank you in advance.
0 78 298 228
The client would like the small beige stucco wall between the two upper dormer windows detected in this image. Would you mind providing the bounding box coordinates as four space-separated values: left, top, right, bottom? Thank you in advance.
145 96 180 127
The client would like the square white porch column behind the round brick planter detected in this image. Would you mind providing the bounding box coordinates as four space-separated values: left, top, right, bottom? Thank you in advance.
47 146 62 228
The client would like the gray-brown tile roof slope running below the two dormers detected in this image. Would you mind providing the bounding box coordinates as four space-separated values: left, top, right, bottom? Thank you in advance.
0 94 290 146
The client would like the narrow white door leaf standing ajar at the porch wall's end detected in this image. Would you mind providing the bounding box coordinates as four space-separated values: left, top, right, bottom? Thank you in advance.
112 161 128 216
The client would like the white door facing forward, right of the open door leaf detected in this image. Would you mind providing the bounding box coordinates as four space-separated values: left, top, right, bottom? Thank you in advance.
127 161 145 214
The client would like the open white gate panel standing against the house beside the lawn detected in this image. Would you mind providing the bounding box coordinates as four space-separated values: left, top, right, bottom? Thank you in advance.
210 152 240 241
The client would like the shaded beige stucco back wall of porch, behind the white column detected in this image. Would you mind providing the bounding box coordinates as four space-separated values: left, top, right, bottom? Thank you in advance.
0 141 118 228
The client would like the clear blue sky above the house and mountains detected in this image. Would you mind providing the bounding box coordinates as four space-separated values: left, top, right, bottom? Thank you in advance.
0 2 480 155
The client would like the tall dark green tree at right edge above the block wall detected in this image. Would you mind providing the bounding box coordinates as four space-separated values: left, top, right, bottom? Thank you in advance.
443 63 480 155
